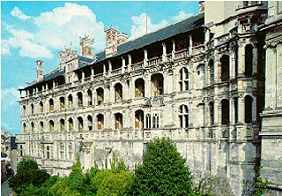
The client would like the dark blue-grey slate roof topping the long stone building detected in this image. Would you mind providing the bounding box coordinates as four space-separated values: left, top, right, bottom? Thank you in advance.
20 14 204 89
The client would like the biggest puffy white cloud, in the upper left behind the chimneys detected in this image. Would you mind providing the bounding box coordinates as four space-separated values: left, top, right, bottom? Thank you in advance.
4 3 105 58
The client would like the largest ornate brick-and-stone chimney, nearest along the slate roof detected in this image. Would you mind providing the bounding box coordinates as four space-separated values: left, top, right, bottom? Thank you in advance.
105 27 128 57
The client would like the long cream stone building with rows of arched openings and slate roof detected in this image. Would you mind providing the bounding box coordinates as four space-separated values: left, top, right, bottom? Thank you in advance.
17 1 281 195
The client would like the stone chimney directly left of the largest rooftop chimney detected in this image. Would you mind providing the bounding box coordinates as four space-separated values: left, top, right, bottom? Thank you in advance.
80 35 95 59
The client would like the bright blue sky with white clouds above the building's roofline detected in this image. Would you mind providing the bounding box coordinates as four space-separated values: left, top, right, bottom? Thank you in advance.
1 1 198 133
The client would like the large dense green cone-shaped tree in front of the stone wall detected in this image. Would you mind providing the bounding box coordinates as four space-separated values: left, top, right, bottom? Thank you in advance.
128 138 193 196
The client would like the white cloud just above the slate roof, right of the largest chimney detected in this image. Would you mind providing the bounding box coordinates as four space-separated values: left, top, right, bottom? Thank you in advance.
130 11 192 39
